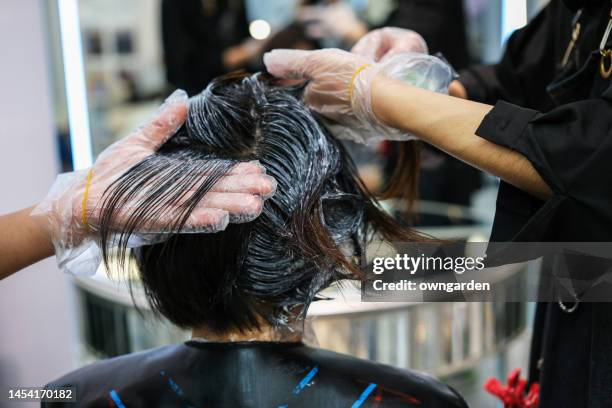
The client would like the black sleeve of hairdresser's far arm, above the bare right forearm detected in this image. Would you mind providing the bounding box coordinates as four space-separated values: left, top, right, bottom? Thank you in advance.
459 0 573 111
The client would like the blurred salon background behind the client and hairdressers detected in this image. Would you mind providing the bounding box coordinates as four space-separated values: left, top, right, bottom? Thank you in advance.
0 0 546 407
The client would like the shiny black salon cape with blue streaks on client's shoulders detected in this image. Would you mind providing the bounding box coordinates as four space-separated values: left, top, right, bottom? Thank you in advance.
42 342 467 408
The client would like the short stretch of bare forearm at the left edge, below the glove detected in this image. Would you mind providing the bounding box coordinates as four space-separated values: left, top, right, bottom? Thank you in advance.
0 208 54 279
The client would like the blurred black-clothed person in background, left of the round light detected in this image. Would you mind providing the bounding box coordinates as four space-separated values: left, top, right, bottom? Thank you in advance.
161 0 261 95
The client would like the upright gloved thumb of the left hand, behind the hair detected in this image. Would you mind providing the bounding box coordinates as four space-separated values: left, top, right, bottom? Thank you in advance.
131 89 189 150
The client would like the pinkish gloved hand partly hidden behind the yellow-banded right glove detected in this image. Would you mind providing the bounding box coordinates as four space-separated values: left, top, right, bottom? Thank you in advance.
351 27 429 62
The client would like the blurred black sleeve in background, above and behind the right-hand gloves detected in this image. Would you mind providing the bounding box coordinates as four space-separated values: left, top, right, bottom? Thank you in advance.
383 0 469 70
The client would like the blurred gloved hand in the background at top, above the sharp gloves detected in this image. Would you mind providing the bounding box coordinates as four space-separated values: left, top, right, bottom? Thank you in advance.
297 2 366 41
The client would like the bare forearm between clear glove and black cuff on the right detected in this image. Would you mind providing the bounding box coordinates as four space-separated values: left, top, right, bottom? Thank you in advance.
372 77 551 198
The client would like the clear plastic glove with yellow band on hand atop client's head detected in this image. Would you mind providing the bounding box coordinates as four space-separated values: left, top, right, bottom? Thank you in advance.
264 49 453 143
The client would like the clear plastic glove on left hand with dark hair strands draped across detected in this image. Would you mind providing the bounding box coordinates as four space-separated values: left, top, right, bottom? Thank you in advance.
32 90 276 275
